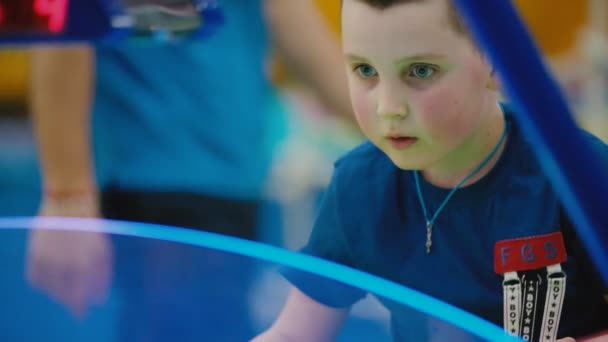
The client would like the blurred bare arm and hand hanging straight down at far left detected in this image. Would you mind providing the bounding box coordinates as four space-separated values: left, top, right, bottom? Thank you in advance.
26 45 113 315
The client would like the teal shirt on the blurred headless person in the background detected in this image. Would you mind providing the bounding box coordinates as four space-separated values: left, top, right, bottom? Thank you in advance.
93 0 272 199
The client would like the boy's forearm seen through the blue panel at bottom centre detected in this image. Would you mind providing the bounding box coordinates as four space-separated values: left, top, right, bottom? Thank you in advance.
253 287 350 342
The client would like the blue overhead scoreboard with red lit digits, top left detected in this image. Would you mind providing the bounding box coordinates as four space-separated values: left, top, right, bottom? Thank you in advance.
0 0 224 45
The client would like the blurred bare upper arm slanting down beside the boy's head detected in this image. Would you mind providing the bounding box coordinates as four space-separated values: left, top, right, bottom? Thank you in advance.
265 0 354 122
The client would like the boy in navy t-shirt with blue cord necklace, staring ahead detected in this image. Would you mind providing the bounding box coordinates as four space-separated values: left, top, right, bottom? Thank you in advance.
256 0 608 341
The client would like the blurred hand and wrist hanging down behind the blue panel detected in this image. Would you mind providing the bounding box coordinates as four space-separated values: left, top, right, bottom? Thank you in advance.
26 192 113 318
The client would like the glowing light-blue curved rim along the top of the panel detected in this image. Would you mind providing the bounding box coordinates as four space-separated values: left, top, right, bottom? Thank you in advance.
0 217 518 341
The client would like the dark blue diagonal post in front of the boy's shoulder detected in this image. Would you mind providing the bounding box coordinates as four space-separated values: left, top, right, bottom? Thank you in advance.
456 0 608 285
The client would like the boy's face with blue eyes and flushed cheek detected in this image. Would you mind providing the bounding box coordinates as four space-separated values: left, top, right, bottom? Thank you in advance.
342 0 496 170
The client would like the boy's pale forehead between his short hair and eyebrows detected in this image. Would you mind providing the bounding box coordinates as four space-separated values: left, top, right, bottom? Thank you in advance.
342 0 462 57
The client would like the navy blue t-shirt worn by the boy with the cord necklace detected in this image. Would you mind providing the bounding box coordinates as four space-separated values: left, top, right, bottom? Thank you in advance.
285 114 608 341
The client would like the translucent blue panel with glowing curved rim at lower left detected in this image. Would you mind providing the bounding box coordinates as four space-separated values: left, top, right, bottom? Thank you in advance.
0 218 511 342
